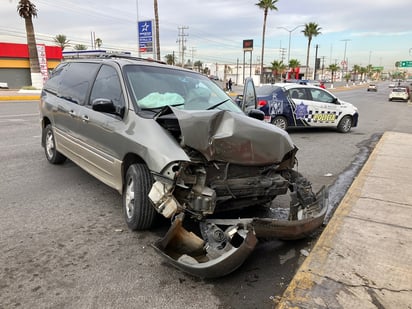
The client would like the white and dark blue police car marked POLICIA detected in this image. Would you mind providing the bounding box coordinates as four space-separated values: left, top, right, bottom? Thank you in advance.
256 83 359 133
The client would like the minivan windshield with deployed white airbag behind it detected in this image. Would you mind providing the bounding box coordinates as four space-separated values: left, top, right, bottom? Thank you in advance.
124 65 242 113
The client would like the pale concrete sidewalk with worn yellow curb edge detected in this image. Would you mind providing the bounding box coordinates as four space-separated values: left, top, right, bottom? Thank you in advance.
276 132 412 309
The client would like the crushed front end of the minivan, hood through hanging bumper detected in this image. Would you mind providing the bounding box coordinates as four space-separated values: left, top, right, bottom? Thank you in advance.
149 107 327 278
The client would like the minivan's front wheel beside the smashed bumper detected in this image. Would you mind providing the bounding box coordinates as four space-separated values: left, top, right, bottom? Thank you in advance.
123 163 158 231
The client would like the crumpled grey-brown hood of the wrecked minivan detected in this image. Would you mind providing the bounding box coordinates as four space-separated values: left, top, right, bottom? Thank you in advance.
172 108 295 165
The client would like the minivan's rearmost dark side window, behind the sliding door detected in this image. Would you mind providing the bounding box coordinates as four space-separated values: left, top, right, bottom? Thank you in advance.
45 62 99 105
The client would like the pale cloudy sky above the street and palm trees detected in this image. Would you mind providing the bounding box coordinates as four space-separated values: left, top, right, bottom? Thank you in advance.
0 0 412 70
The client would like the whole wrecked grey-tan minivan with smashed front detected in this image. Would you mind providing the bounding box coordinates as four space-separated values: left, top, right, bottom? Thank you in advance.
40 55 327 277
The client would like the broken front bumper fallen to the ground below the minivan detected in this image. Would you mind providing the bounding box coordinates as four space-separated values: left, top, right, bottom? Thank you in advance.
154 188 328 278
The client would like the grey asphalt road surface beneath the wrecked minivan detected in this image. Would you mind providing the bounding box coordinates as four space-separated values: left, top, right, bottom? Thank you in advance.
0 84 412 309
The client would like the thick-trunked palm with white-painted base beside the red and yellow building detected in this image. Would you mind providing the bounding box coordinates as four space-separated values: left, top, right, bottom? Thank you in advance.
17 0 43 88
